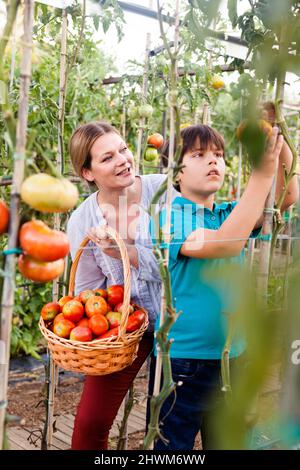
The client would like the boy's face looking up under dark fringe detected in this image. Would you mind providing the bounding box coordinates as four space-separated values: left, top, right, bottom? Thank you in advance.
178 139 225 197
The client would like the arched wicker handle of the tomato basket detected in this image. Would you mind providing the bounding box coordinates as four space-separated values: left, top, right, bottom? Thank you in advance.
68 225 131 337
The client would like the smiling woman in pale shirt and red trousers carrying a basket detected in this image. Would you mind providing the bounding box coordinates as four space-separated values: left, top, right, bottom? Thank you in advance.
67 122 177 450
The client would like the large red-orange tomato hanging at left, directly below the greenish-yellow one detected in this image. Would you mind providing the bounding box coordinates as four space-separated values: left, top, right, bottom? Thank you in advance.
20 220 70 261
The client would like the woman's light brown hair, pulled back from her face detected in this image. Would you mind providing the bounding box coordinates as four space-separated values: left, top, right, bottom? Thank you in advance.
69 121 119 178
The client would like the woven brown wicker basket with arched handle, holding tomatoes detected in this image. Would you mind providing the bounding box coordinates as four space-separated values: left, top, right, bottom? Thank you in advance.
39 227 149 375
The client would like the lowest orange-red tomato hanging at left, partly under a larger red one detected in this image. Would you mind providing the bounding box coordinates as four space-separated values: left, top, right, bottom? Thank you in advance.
18 255 65 282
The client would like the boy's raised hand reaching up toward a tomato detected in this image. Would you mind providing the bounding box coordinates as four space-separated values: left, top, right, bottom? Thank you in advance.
253 127 283 178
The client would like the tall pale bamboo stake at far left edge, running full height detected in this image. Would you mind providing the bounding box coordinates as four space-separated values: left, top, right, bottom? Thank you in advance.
0 0 34 448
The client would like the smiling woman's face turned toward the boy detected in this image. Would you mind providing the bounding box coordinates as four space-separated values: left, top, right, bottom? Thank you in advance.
82 132 135 190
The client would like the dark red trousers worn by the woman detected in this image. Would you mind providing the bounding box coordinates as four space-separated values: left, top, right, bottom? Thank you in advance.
72 333 153 450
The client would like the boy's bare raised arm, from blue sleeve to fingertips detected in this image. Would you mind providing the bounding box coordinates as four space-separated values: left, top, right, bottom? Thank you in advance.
180 127 283 258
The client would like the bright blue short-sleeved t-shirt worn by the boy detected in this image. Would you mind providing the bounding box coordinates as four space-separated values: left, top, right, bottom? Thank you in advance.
150 197 257 359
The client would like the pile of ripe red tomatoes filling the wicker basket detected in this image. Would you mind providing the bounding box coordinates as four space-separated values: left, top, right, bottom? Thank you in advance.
41 285 146 342
